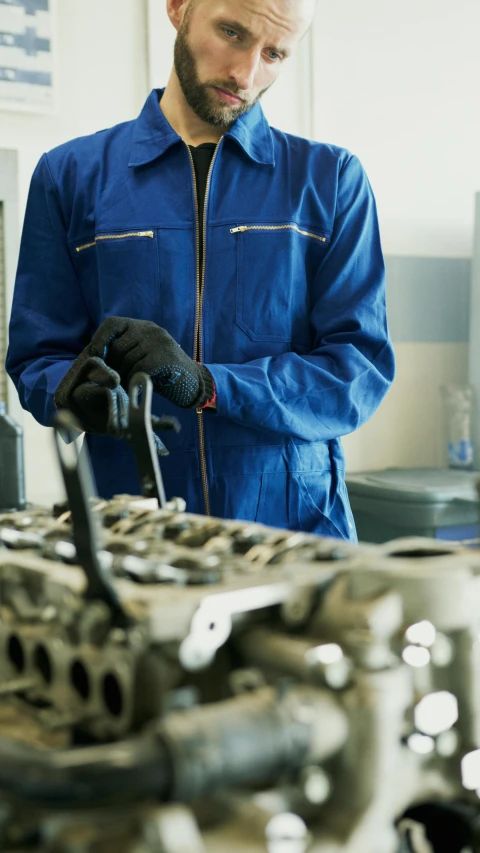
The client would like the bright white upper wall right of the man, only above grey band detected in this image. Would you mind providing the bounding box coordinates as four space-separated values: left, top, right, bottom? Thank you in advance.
315 0 480 257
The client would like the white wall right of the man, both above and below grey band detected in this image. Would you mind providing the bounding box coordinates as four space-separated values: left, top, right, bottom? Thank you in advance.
314 0 480 470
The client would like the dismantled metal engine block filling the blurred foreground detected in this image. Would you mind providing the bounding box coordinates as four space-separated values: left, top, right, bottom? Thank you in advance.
0 394 480 853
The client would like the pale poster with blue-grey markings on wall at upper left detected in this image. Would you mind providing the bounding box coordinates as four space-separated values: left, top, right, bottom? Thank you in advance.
0 0 55 112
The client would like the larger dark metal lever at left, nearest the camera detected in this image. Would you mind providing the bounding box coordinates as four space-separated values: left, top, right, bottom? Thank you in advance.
53 410 129 628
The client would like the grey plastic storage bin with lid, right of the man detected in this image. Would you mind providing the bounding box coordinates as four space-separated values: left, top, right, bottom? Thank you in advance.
346 468 480 542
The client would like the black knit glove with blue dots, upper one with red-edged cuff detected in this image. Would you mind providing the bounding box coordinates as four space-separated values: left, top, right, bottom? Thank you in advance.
89 317 215 409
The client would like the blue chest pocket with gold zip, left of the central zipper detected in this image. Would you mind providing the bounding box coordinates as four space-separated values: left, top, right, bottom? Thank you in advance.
73 230 160 323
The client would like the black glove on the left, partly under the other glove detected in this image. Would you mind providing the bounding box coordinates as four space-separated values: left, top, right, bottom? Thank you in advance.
54 347 129 438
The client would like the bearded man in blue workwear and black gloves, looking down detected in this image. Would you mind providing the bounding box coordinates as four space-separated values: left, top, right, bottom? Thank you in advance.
7 0 394 539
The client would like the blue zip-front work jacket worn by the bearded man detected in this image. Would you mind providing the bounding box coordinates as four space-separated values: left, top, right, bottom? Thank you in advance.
7 90 394 539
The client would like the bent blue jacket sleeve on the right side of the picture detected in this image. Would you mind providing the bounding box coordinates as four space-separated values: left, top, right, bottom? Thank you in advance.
206 155 394 441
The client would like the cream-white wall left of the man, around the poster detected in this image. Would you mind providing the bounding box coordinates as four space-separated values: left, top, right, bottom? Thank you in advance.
0 0 148 504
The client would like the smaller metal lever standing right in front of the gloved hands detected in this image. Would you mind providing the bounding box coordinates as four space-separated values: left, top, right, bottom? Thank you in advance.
127 373 175 507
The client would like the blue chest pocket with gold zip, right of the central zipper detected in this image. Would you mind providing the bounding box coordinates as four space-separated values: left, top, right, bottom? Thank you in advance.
230 223 329 346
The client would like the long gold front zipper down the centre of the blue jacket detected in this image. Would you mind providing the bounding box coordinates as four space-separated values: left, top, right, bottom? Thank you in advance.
185 136 223 515
